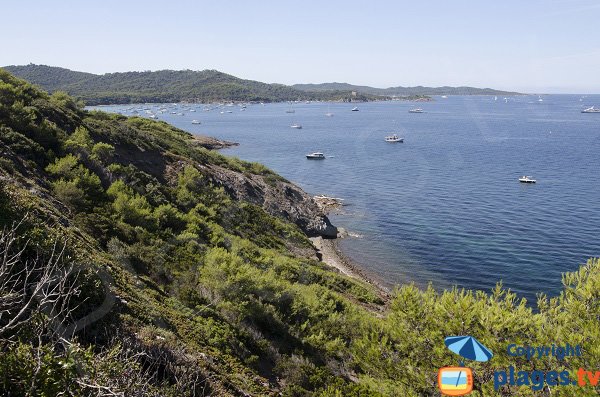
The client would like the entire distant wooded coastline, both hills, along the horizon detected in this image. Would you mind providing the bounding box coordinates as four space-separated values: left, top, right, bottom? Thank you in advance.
3 64 517 105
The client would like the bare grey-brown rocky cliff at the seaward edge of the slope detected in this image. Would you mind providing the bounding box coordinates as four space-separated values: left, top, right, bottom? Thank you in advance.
203 165 337 238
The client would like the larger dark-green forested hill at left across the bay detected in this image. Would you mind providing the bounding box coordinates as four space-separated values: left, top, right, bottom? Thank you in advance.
4 64 382 105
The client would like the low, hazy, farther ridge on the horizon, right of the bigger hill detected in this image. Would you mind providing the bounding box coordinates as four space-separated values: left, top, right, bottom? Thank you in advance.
292 83 520 96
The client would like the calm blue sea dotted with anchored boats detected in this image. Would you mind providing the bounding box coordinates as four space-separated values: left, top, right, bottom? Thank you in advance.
92 95 600 299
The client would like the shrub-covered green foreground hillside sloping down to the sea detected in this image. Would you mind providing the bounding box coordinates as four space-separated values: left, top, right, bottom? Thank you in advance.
0 70 600 397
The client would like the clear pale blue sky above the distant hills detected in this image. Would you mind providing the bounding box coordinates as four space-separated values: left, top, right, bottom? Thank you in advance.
0 0 600 93
